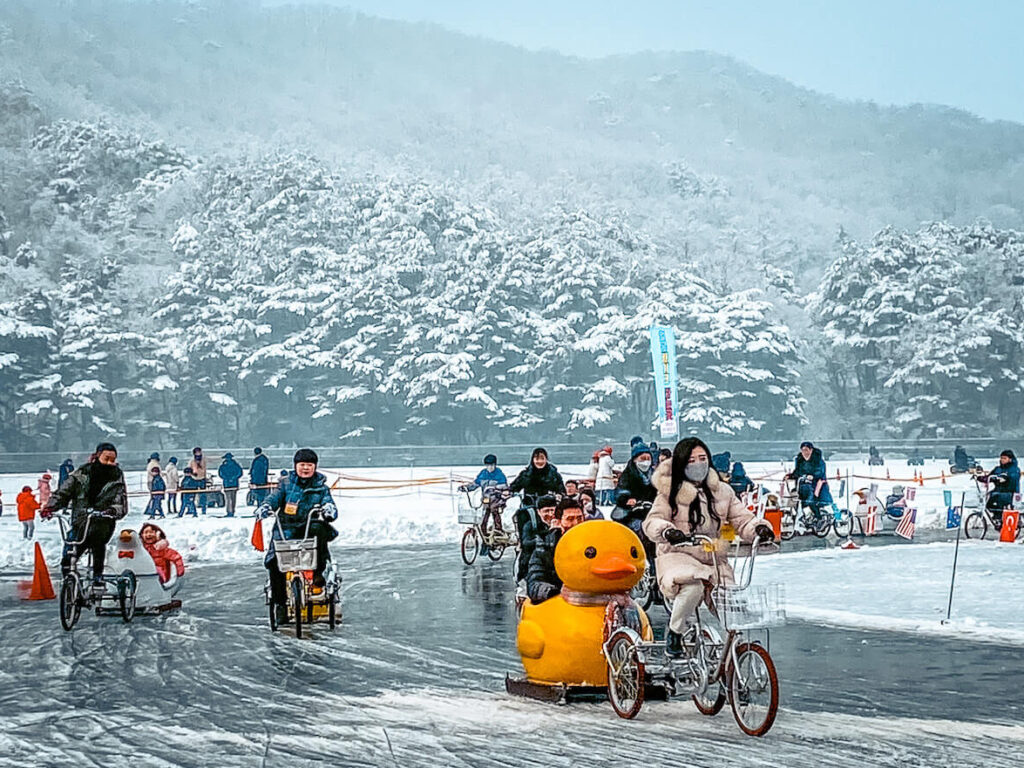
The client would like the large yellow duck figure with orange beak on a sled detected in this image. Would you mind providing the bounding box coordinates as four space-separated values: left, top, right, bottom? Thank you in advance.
516 520 651 685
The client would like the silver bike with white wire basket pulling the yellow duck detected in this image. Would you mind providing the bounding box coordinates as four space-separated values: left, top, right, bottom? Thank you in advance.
603 536 785 736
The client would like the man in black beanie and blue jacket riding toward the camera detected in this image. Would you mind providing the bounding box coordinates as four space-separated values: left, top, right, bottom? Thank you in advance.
256 449 338 624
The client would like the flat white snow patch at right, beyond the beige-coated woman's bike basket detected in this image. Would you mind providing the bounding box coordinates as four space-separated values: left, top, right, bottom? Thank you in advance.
754 541 1024 645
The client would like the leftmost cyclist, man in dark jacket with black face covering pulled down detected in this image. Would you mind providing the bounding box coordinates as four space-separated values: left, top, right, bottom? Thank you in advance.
40 442 128 590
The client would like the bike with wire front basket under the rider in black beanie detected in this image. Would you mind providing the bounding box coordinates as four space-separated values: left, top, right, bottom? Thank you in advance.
263 510 341 638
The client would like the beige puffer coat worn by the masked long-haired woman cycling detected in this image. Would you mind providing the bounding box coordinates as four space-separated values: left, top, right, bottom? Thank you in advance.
643 461 761 599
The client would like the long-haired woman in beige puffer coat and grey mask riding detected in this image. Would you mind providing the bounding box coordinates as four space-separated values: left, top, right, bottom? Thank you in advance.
643 437 774 655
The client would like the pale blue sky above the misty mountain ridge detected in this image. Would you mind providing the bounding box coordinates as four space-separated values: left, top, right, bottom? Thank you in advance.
266 0 1024 123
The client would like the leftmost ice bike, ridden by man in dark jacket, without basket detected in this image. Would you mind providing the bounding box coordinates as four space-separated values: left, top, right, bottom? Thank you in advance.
54 510 138 632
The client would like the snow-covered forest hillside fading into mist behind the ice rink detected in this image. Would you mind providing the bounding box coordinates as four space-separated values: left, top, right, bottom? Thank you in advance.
0 0 1024 451
